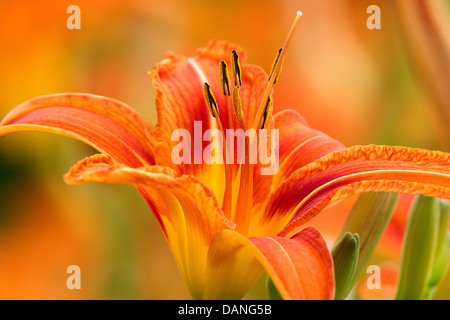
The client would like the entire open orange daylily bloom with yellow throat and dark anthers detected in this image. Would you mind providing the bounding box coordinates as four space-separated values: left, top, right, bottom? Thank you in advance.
0 14 450 299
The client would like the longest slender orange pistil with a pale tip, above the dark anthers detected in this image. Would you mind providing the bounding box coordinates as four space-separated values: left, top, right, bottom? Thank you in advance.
252 11 302 129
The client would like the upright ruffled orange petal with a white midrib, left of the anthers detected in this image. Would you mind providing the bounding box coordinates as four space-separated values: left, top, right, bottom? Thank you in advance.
149 42 242 166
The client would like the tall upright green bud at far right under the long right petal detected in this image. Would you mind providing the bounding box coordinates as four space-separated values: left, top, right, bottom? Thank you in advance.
395 195 440 300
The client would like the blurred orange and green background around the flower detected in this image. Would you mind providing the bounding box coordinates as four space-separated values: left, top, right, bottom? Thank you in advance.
0 0 450 299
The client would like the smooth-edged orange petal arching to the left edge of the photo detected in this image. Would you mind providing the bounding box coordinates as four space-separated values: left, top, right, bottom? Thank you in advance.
0 93 154 167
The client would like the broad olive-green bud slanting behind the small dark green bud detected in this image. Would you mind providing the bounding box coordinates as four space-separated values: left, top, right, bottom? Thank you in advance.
337 192 398 287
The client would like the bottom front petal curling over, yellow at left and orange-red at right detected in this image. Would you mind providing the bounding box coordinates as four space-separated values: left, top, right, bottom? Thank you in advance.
206 228 334 299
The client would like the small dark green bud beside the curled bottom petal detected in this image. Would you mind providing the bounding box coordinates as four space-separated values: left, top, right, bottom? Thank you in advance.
331 232 359 300
